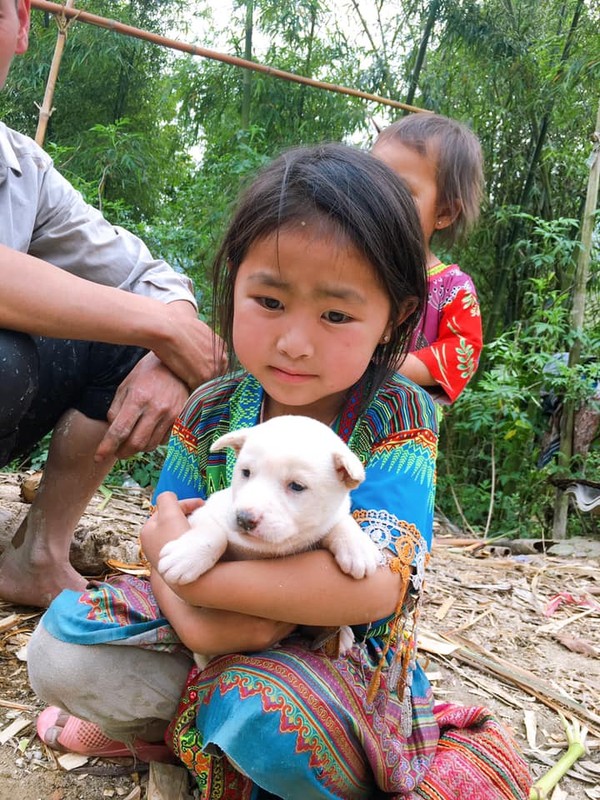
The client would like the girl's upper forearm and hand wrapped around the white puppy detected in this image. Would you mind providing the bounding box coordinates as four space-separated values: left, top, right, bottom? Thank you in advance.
141 492 401 626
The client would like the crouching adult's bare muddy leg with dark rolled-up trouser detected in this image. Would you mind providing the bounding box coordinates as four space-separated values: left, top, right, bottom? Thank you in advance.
0 337 144 606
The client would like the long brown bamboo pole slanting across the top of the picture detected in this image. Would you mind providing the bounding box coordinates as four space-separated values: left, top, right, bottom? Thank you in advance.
31 0 431 114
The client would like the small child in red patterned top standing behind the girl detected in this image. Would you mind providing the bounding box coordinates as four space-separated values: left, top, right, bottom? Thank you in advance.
373 113 483 403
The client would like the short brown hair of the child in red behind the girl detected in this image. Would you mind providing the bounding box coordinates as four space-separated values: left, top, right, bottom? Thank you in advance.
375 113 483 244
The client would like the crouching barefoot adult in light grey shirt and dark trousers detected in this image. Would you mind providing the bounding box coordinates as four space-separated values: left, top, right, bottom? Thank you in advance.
0 0 224 606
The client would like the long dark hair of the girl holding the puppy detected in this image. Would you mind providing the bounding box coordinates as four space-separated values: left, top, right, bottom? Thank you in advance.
213 144 426 396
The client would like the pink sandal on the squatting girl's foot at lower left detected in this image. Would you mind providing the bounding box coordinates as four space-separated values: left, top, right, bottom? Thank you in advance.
37 706 175 762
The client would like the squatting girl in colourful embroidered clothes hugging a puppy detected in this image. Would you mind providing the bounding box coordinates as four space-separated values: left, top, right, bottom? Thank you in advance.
28 145 529 800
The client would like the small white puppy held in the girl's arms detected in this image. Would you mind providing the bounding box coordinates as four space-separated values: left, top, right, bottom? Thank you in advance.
158 416 380 660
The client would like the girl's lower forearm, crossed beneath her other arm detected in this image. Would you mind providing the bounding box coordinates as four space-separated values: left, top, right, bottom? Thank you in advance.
150 570 295 656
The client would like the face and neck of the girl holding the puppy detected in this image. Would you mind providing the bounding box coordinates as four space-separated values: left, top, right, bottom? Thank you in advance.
233 228 392 424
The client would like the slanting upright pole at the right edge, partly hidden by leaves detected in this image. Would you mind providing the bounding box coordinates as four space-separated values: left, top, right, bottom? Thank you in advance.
552 98 600 539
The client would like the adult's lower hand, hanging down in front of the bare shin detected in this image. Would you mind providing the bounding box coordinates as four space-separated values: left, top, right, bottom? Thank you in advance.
95 353 189 461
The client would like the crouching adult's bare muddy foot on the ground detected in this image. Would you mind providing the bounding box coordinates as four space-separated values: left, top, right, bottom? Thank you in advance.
0 544 87 608
